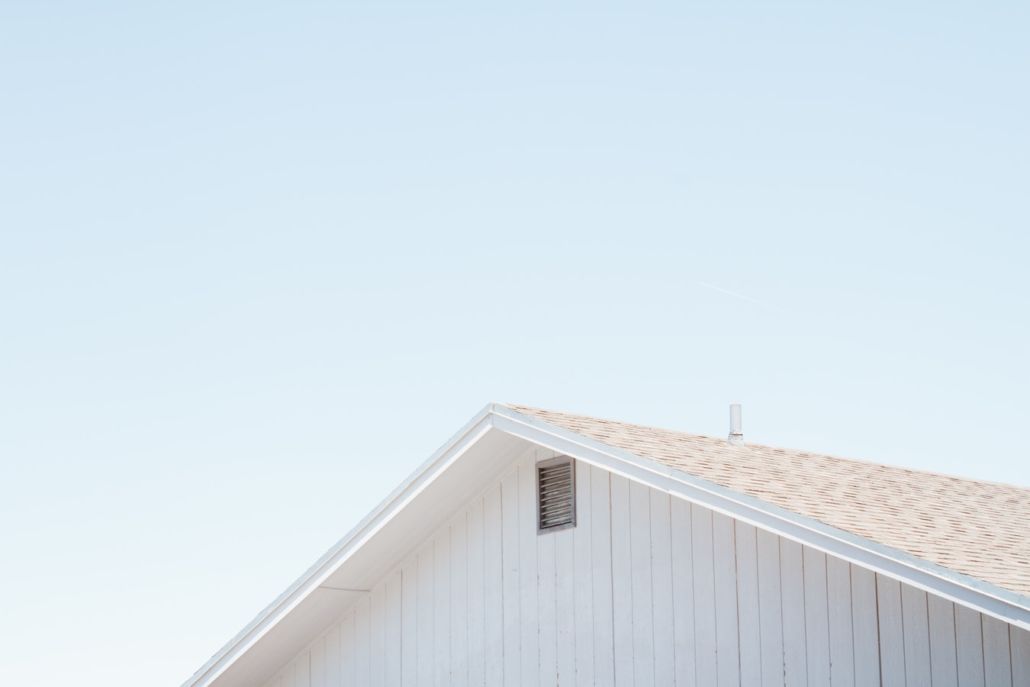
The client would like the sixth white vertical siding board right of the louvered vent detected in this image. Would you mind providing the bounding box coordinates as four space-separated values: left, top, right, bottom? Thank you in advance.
671 500 696 687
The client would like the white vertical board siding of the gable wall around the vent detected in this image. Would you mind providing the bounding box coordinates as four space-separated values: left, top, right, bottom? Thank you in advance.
266 457 1030 687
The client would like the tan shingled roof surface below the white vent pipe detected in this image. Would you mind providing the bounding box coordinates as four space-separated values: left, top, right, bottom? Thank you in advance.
509 406 1030 596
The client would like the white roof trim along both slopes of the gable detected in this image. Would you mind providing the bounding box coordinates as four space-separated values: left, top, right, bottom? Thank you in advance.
182 404 1030 687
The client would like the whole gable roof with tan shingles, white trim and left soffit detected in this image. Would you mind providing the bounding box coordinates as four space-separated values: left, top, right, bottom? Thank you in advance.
183 404 1030 687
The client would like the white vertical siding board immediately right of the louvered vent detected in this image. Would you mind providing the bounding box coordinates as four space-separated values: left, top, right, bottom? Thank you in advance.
573 460 594 687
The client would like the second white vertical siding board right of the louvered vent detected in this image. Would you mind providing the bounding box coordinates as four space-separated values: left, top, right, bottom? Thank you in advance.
589 468 615 687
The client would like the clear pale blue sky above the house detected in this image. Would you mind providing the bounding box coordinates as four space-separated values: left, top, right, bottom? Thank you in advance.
0 0 1030 687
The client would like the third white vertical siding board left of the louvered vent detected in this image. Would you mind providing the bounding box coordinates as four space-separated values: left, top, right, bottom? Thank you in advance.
483 484 505 685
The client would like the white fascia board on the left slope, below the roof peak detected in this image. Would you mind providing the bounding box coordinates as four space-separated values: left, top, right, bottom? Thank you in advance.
182 404 497 687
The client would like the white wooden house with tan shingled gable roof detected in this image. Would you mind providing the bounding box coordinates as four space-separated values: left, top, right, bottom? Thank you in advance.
185 405 1030 687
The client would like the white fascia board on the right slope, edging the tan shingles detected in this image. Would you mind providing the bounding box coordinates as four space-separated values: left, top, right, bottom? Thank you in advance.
492 406 1030 629
